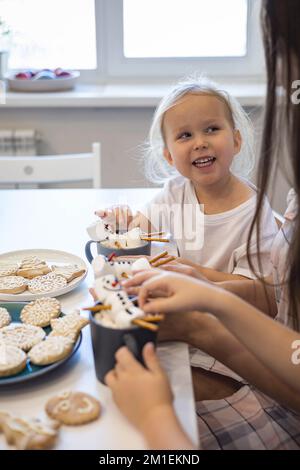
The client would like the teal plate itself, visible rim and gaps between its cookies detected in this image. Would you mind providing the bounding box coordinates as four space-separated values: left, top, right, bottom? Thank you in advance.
0 302 82 386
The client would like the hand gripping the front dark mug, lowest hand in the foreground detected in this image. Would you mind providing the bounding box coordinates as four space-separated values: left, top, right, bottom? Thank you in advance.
105 343 173 430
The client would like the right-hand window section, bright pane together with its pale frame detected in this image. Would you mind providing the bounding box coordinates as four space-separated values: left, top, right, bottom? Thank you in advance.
105 0 264 78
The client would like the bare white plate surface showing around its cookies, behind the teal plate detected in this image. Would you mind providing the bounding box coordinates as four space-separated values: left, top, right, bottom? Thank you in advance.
0 249 88 302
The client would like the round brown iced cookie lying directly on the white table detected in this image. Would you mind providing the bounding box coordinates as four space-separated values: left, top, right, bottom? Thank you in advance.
46 392 101 425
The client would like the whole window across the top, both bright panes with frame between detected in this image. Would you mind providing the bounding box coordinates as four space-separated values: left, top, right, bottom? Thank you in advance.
0 0 264 82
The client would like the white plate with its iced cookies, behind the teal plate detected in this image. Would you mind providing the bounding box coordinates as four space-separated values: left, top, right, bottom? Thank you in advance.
0 249 88 302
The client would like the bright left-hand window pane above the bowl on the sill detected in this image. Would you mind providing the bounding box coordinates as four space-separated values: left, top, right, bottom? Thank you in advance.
0 0 97 70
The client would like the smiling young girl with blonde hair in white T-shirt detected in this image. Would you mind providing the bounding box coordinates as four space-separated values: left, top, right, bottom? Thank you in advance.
96 78 277 282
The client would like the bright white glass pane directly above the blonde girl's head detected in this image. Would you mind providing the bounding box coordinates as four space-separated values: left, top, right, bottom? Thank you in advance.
123 0 248 58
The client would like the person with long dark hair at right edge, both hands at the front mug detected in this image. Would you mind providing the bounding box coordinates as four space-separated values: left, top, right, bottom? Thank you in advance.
106 0 300 449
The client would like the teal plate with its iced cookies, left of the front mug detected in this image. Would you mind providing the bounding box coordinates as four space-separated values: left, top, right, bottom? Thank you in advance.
0 297 89 387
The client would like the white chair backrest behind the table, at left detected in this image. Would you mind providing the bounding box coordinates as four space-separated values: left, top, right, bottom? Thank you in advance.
0 143 101 188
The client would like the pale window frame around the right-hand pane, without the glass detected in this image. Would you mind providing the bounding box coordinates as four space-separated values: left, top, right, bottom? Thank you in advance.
101 0 264 79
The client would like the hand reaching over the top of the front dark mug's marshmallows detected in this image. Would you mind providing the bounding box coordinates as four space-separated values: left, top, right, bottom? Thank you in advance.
136 273 224 313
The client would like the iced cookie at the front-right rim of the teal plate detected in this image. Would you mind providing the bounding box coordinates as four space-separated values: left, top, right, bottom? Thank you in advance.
28 336 74 366
